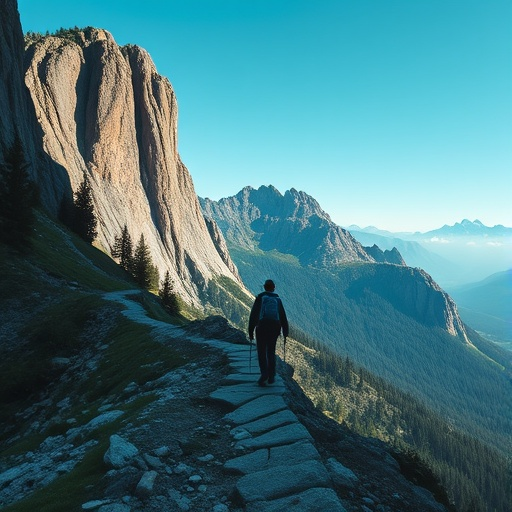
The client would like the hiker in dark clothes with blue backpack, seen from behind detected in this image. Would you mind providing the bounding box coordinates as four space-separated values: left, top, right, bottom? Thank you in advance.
249 279 288 386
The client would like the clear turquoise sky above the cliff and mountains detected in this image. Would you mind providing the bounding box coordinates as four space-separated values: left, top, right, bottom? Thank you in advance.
18 0 512 231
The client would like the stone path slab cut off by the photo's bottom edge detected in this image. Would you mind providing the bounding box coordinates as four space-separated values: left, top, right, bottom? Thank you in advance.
245 488 346 512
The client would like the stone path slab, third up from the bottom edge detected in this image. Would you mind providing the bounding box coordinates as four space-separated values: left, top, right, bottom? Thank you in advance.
224 441 320 475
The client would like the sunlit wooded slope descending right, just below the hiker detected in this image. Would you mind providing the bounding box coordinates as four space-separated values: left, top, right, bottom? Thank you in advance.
281 332 512 511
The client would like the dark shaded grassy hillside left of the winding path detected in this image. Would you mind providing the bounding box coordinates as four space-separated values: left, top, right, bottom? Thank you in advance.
0 214 186 442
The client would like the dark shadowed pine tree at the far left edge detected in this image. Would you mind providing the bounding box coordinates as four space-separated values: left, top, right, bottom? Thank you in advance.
0 135 37 249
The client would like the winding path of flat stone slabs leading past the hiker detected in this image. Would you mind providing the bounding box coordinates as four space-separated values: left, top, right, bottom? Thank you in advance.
106 292 345 512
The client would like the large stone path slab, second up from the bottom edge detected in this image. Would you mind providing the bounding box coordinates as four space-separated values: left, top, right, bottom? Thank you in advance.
236 460 331 504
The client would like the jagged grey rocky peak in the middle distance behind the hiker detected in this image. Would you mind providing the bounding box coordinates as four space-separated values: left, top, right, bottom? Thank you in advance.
200 186 375 268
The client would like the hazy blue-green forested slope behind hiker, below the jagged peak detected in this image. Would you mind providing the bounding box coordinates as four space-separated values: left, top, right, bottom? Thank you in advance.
231 245 512 453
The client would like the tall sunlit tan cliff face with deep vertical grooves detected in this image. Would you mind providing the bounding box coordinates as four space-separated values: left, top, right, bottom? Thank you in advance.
20 28 242 305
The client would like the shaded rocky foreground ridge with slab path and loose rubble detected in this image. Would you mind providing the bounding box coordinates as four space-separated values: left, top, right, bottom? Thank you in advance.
0 291 445 512
